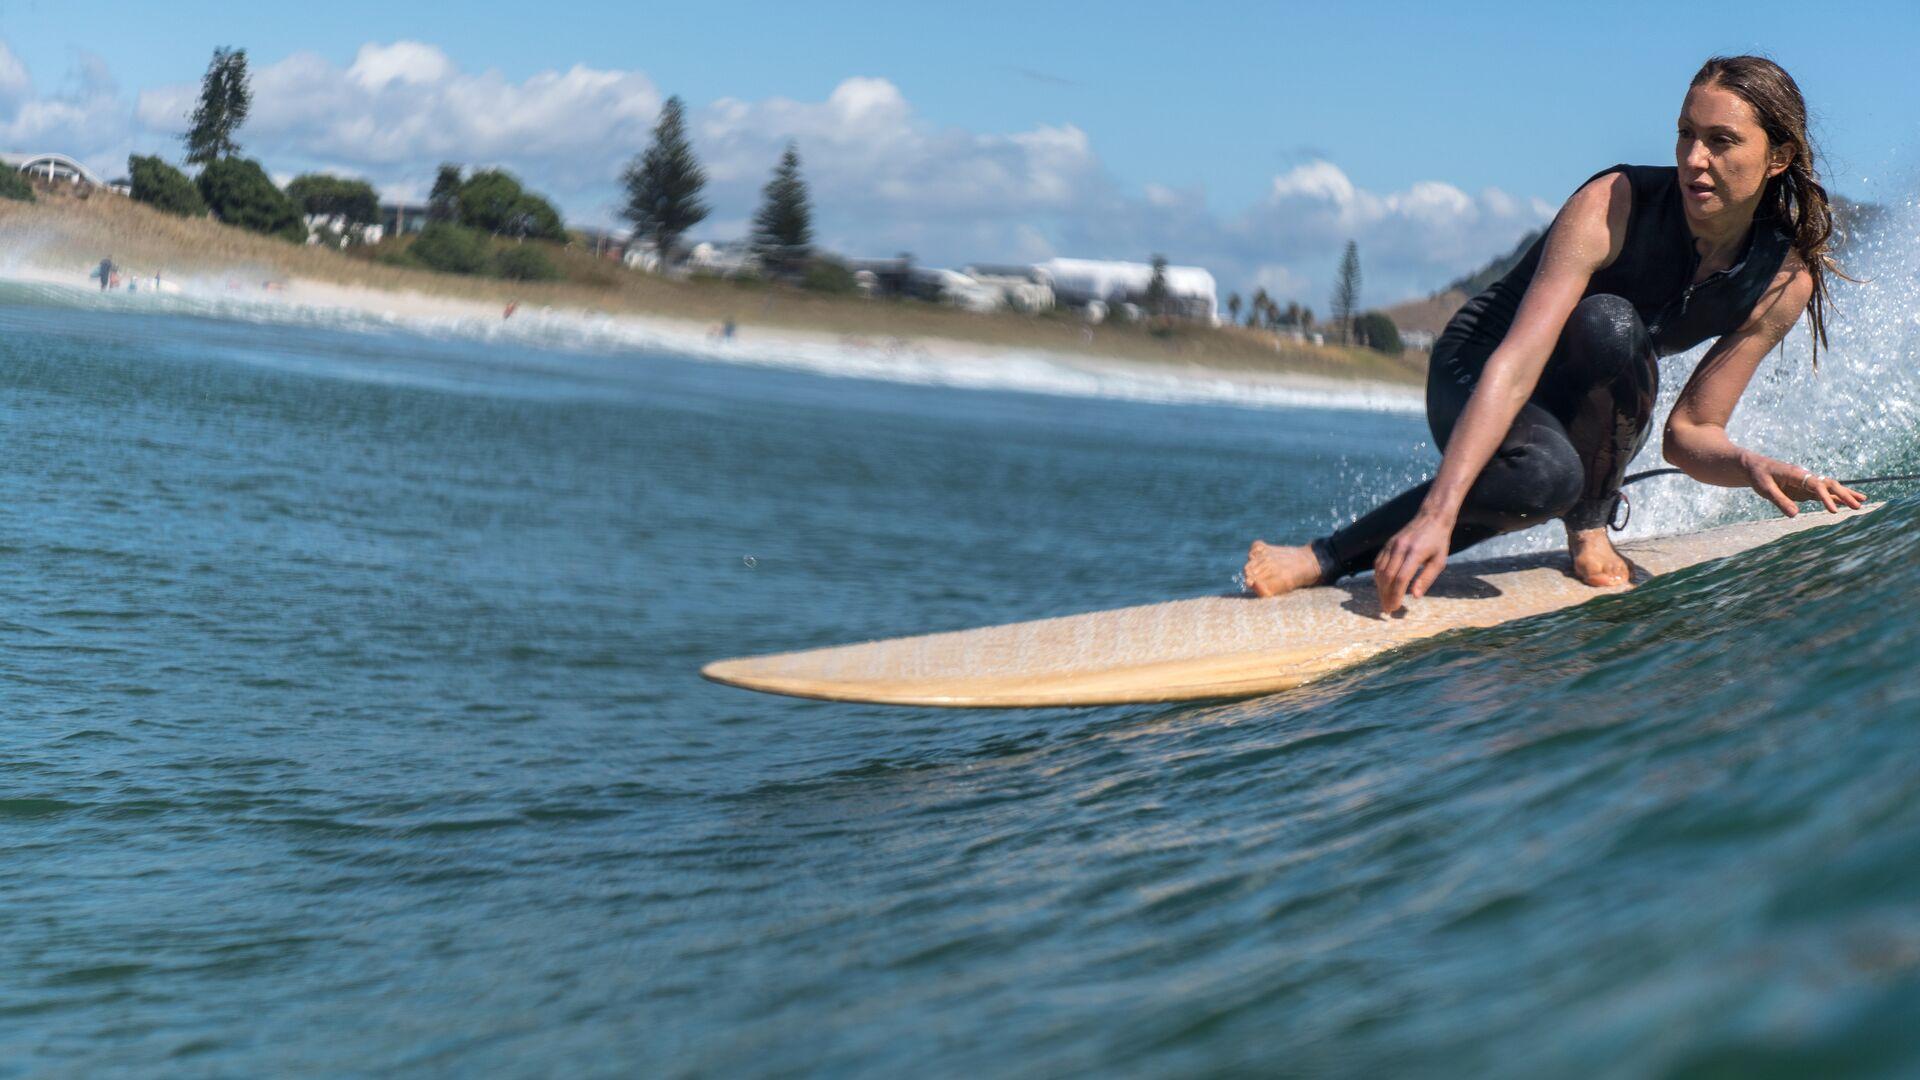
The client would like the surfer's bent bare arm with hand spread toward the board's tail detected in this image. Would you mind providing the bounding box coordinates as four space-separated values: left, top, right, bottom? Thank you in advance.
1661 254 1864 517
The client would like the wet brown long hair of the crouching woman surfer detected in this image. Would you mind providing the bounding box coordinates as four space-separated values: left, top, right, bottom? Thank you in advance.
1688 56 1853 369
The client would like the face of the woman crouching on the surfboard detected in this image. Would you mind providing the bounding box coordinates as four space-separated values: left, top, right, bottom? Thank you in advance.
1674 85 1793 221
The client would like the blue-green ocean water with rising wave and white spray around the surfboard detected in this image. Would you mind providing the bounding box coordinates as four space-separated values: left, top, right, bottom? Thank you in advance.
0 245 1920 1076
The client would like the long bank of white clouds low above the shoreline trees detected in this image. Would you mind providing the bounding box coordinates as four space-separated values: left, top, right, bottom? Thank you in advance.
0 40 1553 306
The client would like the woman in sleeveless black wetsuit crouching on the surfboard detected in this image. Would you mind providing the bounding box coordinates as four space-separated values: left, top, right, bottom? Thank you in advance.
1246 56 1864 611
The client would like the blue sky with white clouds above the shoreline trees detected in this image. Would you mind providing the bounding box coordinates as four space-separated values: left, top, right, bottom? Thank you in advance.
0 0 1920 307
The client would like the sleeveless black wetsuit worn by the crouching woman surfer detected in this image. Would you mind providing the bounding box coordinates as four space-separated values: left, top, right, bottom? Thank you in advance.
1313 165 1791 580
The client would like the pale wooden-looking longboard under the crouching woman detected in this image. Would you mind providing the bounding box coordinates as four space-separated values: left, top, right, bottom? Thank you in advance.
701 503 1880 709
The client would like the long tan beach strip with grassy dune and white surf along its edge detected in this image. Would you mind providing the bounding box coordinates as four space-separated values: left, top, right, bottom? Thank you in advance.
0 187 1421 411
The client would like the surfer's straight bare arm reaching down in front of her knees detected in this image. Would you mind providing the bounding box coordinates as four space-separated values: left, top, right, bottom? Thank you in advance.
1375 173 1634 611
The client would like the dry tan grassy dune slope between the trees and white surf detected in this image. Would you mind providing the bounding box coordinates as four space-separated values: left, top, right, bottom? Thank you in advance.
0 192 1425 382
